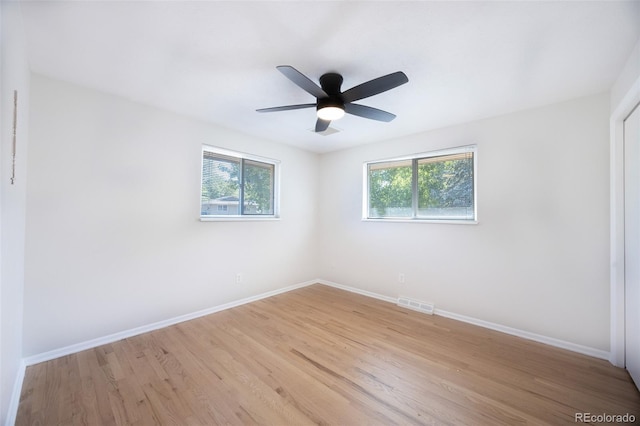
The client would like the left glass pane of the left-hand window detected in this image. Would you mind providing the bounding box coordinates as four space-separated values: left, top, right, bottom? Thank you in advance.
200 152 240 216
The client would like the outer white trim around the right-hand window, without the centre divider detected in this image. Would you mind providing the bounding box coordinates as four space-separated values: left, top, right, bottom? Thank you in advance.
362 144 478 225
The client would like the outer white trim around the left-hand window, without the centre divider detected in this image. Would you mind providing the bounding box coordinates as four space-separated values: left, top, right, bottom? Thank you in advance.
198 145 281 222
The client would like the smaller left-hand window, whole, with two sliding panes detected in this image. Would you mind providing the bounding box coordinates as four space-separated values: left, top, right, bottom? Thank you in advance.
200 146 278 219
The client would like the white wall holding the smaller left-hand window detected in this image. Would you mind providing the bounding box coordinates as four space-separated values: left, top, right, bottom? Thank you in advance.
24 75 318 357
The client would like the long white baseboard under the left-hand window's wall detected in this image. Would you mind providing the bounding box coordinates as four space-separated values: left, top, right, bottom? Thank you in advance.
23 280 318 366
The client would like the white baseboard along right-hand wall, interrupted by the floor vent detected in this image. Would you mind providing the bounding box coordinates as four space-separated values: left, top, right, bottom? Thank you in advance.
317 279 610 360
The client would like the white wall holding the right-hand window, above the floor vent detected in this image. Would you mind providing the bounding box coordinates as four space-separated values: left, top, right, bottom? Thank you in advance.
319 94 609 351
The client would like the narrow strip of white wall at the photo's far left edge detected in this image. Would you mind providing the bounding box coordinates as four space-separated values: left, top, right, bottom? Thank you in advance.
0 2 29 424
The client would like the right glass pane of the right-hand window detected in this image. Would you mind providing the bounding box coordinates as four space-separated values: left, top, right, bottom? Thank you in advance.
417 152 474 219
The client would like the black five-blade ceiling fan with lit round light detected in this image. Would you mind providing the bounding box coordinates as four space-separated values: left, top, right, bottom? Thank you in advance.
256 65 409 132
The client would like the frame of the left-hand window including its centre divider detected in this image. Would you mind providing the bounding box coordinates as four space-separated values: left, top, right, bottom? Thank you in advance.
199 145 280 222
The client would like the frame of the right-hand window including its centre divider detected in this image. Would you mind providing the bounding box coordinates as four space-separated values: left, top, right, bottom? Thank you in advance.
362 144 478 225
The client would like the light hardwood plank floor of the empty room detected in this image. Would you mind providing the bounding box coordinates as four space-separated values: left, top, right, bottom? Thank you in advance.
16 285 640 425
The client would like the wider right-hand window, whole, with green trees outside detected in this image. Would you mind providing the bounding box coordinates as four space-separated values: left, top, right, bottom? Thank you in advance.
364 146 476 221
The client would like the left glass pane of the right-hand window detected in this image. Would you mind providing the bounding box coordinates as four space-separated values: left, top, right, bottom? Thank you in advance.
368 160 413 217
